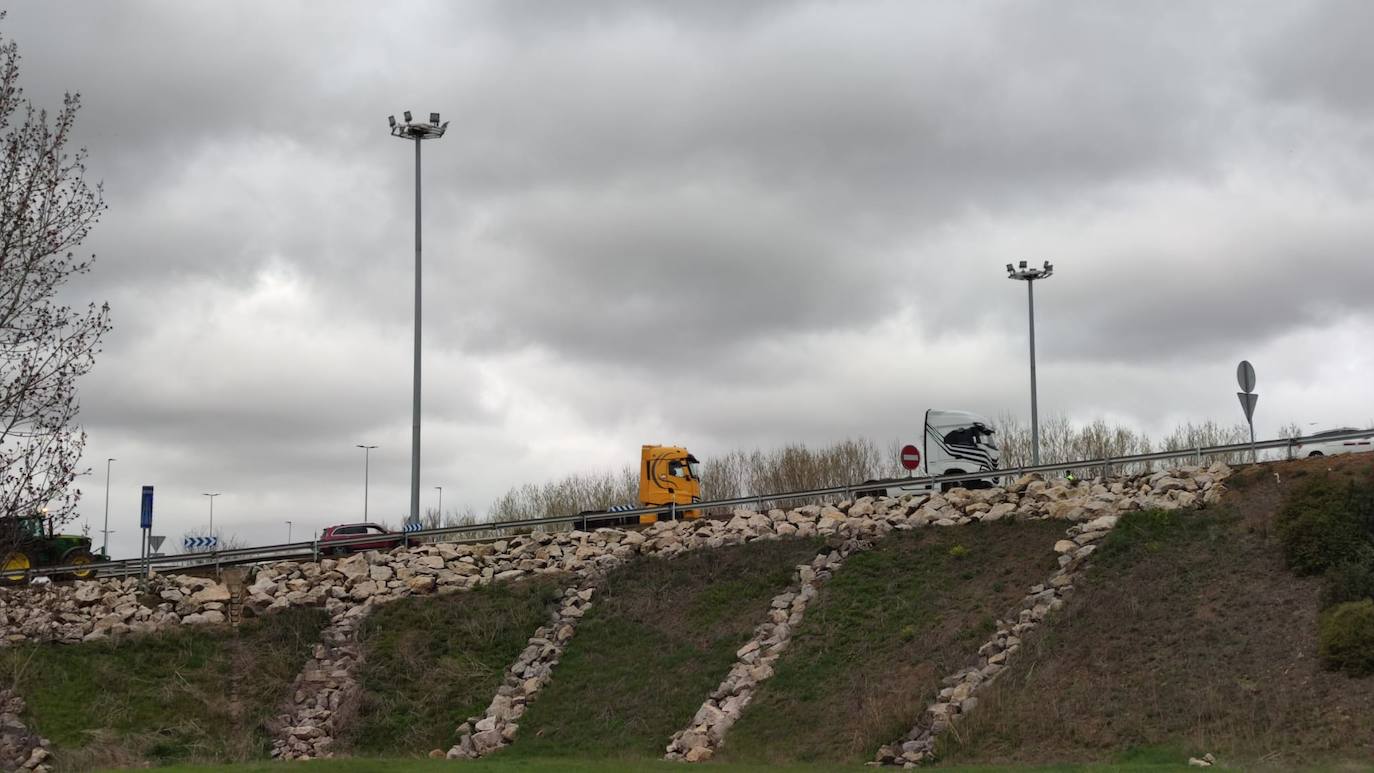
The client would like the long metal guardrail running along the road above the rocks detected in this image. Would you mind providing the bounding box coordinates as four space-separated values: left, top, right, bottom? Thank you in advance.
13 430 1374 577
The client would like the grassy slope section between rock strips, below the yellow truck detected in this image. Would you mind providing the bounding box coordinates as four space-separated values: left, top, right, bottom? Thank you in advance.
500 540 819 758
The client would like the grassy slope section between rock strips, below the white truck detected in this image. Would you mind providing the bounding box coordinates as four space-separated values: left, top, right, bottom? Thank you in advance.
723 522 1063 762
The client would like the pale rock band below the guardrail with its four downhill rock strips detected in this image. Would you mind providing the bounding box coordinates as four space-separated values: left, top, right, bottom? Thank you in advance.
0 464 1230 763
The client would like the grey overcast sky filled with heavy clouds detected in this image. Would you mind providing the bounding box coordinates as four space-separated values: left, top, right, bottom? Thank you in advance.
0 0 1374 555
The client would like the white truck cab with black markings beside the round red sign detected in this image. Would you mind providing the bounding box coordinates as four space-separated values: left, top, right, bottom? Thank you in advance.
856 411 1002 497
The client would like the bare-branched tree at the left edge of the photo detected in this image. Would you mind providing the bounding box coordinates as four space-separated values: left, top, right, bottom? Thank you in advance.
0 14 110 538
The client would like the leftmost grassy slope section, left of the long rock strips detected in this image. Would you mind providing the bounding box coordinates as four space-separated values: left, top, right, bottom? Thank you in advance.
0 610 327 769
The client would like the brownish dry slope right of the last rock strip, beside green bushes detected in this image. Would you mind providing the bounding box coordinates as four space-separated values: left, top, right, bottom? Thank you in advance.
944 454 1374 769
